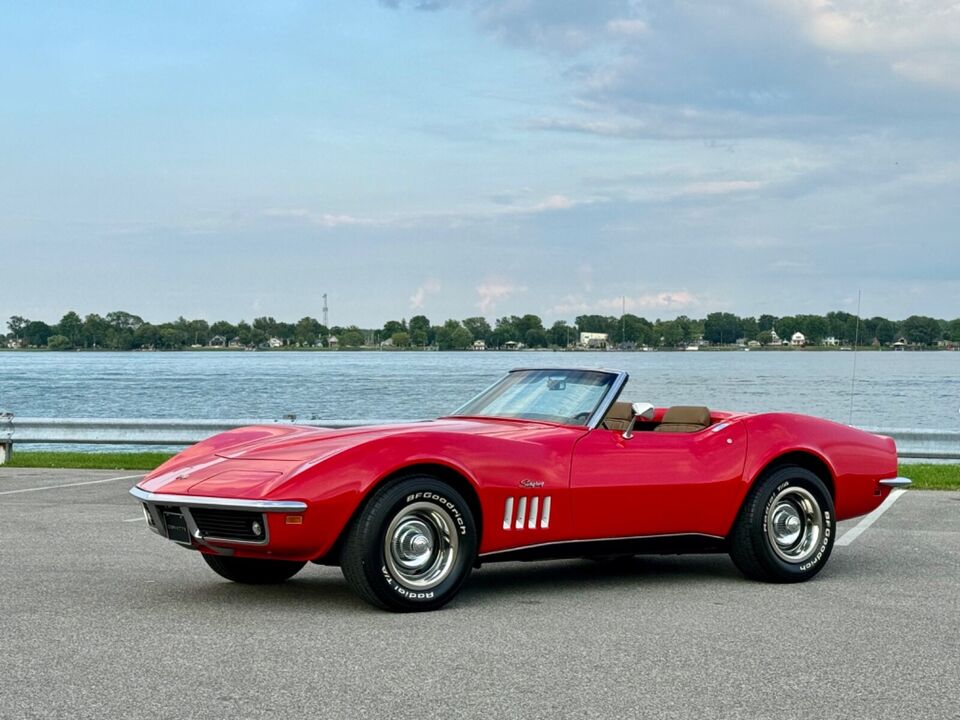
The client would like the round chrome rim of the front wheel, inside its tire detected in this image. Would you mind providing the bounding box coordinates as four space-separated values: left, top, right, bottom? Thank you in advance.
383 502 460 591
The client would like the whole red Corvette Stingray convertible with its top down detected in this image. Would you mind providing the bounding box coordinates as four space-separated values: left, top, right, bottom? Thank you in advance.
131 369 910 611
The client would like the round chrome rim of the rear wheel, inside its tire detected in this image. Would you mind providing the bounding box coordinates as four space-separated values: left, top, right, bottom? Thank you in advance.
764 486 825 564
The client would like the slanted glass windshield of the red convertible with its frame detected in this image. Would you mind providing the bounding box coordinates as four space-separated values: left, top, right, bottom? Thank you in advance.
454 370 617 425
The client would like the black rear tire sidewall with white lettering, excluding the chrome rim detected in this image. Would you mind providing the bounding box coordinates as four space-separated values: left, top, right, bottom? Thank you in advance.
751 467 837 581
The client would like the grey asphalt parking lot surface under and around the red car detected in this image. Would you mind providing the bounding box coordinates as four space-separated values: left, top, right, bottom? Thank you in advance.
0 468 960 720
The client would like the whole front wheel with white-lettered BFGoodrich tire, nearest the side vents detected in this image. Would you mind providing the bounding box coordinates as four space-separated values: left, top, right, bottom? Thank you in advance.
340 475 477 612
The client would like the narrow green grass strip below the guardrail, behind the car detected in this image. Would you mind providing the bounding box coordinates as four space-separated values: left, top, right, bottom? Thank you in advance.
0 452 960 490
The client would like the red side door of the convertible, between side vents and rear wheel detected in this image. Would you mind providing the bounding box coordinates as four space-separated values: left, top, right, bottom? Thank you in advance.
570 422 747 538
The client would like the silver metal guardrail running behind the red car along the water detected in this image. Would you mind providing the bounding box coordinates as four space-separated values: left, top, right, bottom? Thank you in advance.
0 412 960 464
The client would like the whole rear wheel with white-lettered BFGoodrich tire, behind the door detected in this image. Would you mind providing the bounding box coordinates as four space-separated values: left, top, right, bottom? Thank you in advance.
730 465 837 582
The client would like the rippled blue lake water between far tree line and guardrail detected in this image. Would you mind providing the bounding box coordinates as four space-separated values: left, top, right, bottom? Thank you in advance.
0 351 960 430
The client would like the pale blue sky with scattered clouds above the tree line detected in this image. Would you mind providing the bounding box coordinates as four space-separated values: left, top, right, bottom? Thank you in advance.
0 0 960 326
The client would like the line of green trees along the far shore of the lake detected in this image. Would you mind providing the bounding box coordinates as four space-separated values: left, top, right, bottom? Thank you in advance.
6 311 960 350
